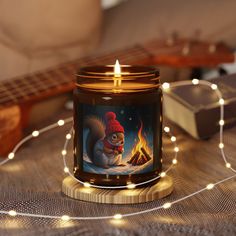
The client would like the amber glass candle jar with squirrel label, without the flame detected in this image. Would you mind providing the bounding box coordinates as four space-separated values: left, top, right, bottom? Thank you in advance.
74 63 162 186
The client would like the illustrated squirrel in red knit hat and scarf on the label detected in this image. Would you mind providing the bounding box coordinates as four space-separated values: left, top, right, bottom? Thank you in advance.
84 112 125 169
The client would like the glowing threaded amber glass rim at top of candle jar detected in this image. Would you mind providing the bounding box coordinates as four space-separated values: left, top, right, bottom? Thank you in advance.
76 65 160 93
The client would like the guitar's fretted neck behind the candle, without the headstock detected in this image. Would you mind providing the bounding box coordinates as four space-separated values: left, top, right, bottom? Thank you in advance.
0 45 151 107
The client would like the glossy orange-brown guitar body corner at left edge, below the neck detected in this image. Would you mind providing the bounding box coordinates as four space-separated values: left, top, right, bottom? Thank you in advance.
0 105 22 156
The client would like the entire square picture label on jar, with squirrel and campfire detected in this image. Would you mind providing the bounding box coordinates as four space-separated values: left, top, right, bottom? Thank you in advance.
79 104 161 175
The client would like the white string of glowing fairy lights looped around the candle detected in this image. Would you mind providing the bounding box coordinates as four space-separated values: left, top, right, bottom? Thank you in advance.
0 79 236 221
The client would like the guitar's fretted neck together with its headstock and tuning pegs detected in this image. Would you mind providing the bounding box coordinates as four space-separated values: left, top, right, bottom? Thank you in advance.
0 39 234 107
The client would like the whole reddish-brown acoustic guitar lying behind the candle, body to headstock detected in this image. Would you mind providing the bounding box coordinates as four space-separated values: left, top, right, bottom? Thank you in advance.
0 39 234 156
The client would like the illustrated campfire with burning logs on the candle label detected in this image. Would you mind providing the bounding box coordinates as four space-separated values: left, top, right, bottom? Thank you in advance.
127 122 152 166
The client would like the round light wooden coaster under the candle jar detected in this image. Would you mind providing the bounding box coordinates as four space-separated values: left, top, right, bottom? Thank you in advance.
62 176 173 204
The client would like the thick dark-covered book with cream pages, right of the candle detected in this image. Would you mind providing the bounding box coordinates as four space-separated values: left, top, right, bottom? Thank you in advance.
164 74 236 139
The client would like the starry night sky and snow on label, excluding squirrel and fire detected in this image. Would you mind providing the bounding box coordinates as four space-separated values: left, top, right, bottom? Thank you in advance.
83 104 153 175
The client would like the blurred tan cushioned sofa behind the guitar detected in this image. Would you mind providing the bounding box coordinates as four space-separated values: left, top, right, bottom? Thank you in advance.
0 0 236 81
